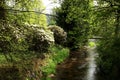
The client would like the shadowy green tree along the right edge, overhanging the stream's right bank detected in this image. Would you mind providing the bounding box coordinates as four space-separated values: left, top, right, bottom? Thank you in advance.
93 0 120 79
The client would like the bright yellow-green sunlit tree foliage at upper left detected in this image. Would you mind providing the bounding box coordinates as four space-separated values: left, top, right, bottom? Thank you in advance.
0 0 47 27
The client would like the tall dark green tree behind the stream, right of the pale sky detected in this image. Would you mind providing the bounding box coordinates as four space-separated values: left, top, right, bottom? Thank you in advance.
56 0 89 49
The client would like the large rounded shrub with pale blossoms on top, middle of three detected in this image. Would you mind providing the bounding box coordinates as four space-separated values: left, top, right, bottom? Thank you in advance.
26 26 54 53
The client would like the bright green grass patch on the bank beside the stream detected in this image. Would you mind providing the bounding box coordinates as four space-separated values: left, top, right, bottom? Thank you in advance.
41 46 69 78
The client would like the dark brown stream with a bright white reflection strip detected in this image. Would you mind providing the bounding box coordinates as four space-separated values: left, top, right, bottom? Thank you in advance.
56 40 98 80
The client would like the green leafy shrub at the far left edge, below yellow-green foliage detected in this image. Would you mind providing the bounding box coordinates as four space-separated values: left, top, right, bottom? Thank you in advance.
0 21 23 53
